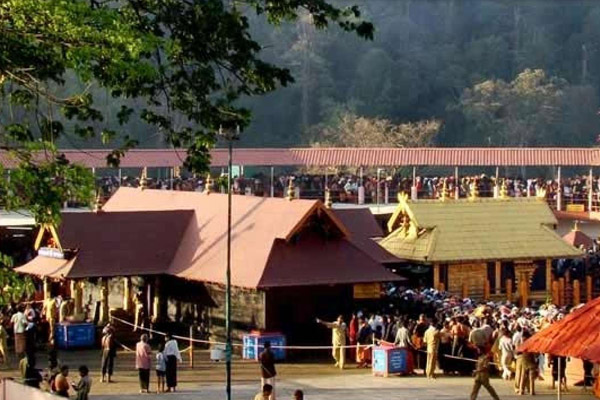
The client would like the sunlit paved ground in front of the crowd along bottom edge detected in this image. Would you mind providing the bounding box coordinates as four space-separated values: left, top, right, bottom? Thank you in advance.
0 350 594 400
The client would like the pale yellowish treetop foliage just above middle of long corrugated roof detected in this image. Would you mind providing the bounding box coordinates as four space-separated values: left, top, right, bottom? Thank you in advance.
312 112 441 147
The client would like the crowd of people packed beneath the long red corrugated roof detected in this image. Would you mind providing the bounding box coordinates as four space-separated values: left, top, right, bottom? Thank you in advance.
91 173 600 208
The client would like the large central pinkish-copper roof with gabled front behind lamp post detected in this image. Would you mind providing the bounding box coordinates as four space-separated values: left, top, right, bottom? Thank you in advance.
104 188 401 288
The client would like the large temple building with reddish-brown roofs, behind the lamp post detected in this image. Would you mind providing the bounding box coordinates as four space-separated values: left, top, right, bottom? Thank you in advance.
17 188 403 344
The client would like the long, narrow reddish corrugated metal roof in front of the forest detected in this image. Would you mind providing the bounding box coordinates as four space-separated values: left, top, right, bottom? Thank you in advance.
0 147 600 168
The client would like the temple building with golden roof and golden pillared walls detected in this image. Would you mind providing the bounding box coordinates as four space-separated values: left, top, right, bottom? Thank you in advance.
379 194 583 304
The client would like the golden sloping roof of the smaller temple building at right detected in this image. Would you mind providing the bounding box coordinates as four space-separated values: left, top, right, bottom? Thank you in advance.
380 198 582 262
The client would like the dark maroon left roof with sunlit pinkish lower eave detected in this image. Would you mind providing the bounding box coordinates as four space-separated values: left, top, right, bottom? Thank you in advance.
17 210 194 278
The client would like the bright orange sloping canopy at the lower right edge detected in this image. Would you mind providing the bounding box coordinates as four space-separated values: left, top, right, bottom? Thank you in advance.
518 298 600 362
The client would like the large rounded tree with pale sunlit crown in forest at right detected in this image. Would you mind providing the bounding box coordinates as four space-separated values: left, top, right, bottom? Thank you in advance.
456 69 597 146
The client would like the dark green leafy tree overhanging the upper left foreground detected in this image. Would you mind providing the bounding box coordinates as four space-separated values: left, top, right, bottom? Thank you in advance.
0 0 374 222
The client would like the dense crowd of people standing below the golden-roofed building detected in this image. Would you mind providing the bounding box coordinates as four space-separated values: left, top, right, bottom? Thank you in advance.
317 289 593 398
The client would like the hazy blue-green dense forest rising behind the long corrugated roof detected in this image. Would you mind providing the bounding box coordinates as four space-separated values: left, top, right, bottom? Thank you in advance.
43 0 600 147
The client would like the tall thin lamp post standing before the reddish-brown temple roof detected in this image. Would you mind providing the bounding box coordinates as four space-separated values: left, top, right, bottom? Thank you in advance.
219 126 240 400
